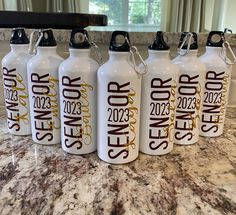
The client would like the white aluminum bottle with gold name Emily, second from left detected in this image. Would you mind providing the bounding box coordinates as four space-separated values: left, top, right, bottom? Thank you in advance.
27 30 63 145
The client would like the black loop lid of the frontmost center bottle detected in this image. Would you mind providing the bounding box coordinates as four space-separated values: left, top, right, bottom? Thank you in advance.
109 31 130 52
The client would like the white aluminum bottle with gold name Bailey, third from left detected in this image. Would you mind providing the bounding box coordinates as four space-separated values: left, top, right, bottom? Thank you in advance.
59 29 99 154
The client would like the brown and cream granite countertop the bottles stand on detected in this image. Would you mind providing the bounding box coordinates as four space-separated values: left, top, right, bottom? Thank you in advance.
0 108 236 215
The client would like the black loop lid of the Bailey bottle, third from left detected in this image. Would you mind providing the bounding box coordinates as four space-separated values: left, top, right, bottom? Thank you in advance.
69 28 91 49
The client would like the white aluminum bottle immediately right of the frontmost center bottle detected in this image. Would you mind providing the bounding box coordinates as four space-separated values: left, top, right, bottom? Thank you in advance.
140 31 179 155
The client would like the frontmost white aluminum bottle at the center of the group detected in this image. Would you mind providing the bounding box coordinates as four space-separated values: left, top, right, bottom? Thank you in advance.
97 31 141 164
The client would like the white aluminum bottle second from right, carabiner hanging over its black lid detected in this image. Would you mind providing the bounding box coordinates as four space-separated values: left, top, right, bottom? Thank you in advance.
173 32 205 145
